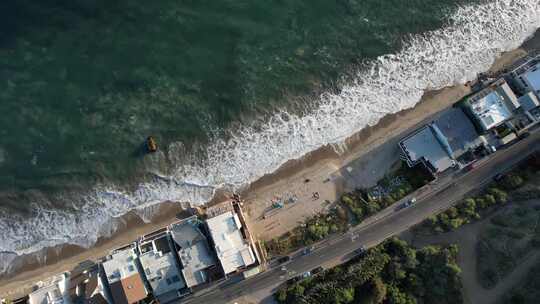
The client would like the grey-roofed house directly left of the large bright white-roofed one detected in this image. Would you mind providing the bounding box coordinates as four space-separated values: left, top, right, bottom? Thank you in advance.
168 215 217 289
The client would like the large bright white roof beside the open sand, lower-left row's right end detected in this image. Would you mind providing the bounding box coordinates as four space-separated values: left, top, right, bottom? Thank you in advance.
206 211 255 274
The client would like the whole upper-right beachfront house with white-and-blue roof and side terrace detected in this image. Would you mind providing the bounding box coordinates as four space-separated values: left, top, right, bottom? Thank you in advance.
463 78 521 132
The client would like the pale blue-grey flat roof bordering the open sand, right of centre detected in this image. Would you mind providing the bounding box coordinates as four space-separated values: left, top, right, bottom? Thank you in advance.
400 125 454 172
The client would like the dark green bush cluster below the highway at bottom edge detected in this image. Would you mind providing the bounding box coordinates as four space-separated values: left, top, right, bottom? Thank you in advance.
275 238 463 304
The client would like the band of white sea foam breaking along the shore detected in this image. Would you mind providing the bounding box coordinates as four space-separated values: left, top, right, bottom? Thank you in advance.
0 0 540 266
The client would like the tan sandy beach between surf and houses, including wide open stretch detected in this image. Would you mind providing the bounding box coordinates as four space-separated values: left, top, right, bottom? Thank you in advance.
0 31 540 298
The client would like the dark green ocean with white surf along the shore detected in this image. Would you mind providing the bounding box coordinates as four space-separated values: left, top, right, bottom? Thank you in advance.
0 0 540 270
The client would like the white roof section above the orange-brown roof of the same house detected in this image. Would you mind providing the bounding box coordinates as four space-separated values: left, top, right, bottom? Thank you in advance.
102 248 139 284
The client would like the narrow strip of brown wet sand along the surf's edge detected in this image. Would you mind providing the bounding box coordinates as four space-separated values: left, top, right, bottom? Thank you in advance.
0 31 540 296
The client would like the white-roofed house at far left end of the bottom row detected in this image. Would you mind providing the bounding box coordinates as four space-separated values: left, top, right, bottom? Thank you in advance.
28 272 72 304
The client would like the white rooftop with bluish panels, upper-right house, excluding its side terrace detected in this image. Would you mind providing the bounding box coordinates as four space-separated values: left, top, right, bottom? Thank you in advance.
471 90 512 130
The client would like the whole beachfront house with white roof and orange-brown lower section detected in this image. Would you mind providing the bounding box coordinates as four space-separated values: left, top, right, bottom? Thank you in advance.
100 244 149 304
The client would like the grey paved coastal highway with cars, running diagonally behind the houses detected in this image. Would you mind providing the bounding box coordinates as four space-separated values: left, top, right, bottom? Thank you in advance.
185 132 540 304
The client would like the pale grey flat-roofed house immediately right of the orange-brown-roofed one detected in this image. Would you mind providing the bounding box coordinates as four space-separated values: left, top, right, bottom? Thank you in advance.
139 233 186 297
